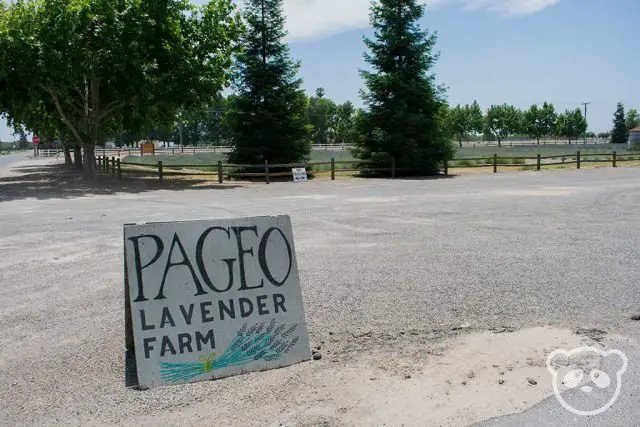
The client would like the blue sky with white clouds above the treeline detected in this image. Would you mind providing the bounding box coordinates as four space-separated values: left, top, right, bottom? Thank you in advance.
0 0 640 140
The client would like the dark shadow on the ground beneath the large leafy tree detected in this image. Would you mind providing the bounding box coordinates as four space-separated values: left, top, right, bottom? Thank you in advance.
0 164 243 202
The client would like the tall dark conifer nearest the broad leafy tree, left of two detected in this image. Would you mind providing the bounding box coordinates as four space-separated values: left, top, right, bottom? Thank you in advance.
228 0 310 164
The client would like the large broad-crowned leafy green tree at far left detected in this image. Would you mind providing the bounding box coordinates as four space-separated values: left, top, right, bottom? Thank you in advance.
0 0 241 176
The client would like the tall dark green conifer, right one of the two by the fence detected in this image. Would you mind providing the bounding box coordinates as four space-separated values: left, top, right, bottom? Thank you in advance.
355 0 454 175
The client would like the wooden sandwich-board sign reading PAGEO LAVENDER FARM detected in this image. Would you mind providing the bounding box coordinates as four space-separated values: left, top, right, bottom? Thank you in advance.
124 216 311 388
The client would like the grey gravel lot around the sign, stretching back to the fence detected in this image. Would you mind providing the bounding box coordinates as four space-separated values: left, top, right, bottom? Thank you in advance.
0 160 640 425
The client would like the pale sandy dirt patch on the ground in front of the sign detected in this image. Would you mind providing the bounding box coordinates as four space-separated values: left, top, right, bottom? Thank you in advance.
122 328 588 427
